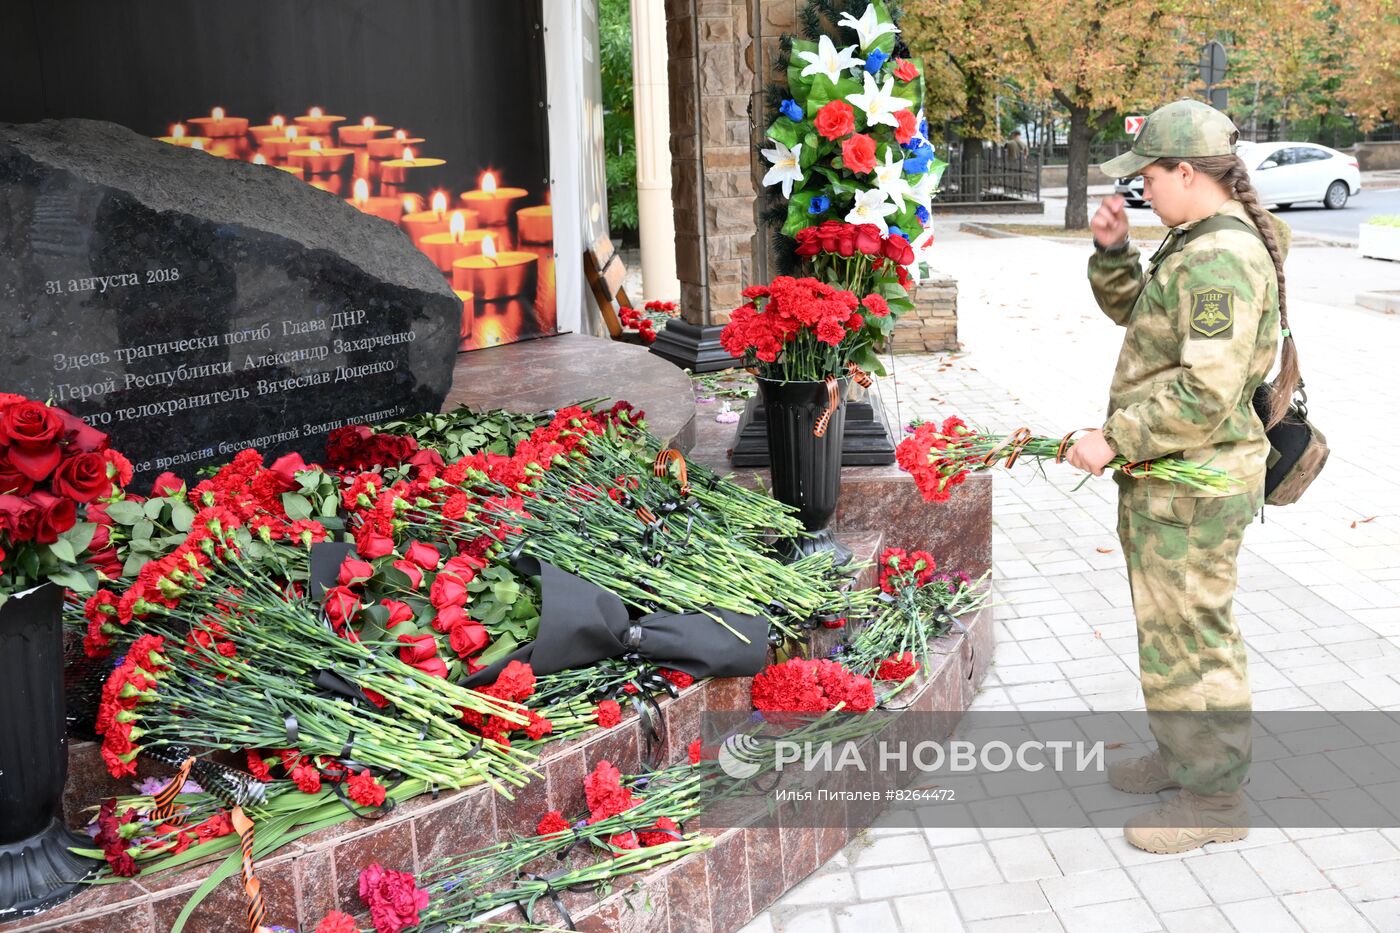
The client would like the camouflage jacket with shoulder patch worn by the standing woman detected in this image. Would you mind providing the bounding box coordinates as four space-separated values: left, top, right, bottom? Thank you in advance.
1089 199 1289 496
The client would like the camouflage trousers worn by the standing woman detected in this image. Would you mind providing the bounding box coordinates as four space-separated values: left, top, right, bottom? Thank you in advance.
1119 481 1263 794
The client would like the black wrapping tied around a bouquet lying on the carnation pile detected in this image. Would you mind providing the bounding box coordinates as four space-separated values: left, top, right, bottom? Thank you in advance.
463 551 769 686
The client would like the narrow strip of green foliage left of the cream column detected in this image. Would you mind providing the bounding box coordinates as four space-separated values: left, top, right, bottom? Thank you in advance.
598 0 637 233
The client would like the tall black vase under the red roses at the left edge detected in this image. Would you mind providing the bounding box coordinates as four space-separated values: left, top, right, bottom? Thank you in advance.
0 583 99 919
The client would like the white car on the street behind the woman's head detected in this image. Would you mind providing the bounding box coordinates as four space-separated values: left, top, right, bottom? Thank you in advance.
1113 143 1361 210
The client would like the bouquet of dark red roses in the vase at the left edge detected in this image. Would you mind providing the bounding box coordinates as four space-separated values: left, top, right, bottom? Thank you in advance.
0 394 132 604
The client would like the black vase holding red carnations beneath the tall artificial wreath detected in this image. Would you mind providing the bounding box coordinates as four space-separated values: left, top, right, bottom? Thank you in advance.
757 377 853 567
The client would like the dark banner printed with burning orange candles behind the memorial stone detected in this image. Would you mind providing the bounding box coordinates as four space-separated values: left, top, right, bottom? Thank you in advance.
0 0 557 350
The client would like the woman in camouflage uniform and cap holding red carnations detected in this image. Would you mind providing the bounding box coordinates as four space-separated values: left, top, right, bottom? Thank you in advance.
1068 101 1298 853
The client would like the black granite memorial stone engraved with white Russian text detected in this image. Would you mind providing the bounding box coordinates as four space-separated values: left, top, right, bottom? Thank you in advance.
0 120 462 485
